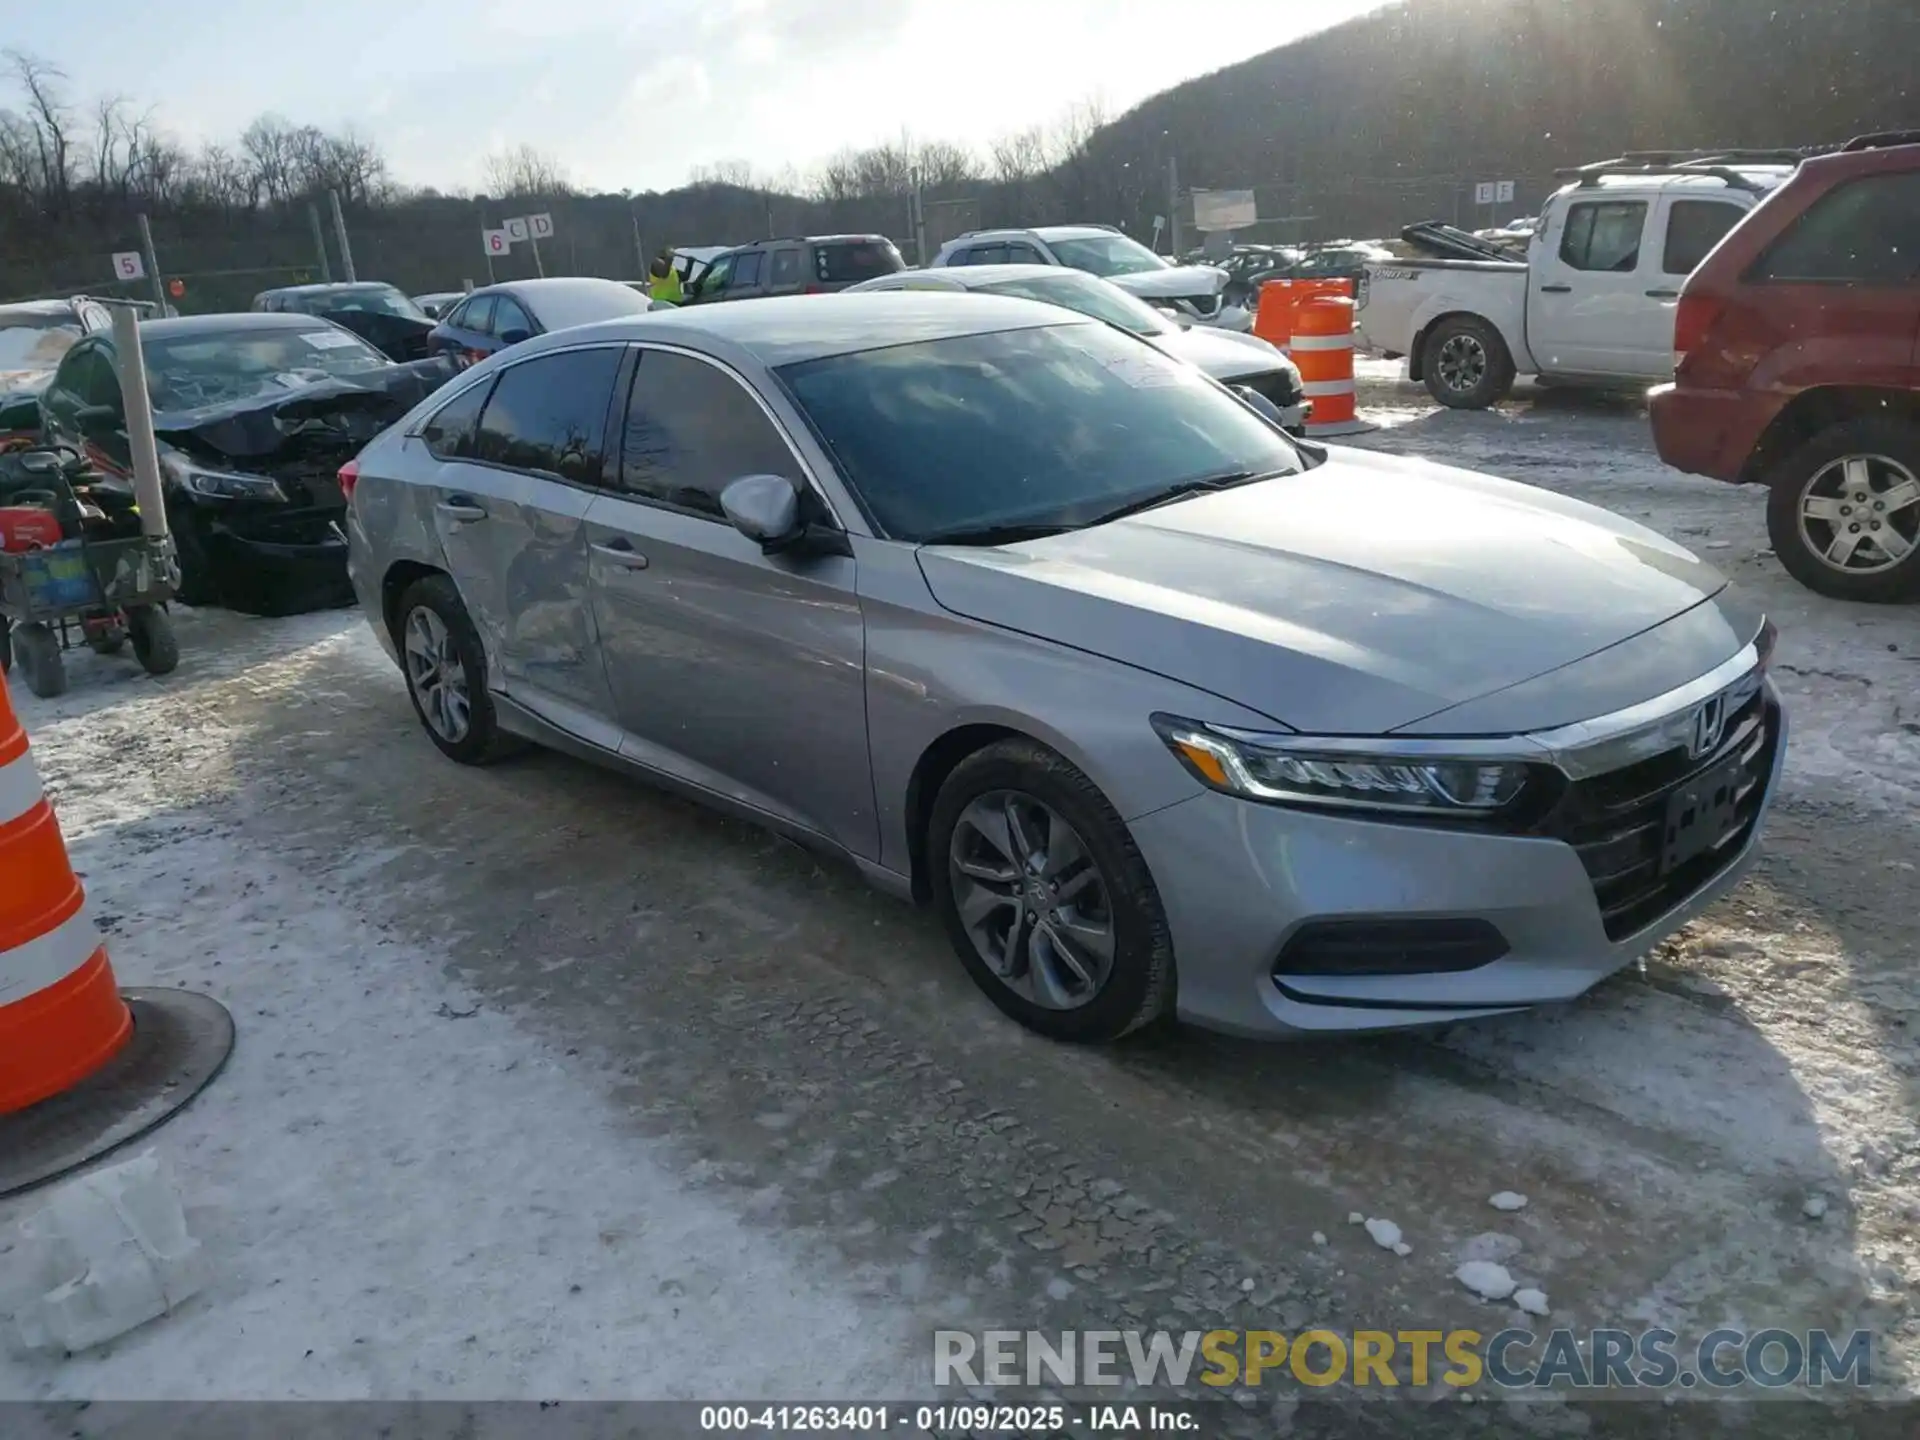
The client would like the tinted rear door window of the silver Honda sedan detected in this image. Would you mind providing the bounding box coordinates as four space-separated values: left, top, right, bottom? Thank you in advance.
474 346 620 484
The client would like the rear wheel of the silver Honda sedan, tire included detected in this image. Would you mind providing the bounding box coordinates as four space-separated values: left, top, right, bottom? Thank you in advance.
394 574 522 764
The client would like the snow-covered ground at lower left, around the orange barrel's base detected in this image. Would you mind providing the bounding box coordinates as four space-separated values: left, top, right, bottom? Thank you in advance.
0 614 920 1400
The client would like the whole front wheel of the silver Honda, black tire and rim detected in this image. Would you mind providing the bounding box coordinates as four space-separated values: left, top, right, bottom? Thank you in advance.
927 739 1175 1044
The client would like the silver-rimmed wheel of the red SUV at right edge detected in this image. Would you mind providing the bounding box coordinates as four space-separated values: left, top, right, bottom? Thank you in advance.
1766 415 1920 605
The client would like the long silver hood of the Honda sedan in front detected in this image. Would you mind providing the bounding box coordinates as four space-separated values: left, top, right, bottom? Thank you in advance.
920 449 1743 735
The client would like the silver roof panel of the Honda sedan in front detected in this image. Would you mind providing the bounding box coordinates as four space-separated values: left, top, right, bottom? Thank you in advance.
533 290 1094 369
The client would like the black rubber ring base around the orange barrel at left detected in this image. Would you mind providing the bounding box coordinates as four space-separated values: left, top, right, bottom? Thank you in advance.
0 991 234 1198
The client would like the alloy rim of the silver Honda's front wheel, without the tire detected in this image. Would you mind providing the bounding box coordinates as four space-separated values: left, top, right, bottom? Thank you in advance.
947 791 1116 1010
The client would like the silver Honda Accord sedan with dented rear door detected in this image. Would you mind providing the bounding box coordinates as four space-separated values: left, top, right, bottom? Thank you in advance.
342 294 1786 1041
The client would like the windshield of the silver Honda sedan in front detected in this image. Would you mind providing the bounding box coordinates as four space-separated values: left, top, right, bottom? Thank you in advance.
778 323 1300 541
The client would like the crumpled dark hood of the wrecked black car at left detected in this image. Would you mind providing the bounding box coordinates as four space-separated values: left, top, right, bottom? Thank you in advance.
154 357 457 476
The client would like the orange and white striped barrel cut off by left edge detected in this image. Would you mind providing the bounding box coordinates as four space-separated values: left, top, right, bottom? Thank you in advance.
0 680 132 1116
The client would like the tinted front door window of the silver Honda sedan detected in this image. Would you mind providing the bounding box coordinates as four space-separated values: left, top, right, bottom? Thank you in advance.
620 349 799 518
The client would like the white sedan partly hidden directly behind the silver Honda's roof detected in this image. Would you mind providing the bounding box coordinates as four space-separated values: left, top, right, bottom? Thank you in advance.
847 265 1313 436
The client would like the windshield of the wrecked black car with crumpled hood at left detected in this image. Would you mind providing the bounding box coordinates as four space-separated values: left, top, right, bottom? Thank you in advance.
142 324 392 411
